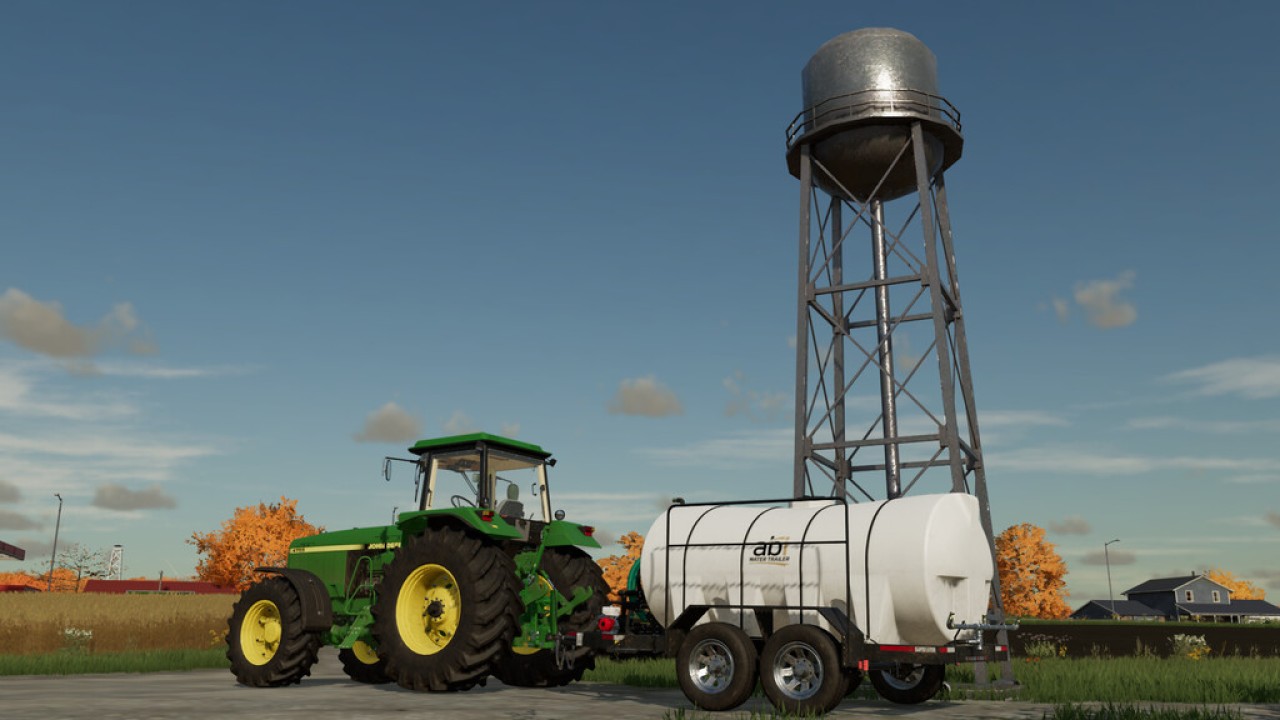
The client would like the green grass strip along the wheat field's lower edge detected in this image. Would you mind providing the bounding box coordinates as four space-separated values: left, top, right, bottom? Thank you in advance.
0 647 228 675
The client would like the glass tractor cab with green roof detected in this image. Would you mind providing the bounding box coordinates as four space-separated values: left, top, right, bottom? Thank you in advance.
410 433 556 523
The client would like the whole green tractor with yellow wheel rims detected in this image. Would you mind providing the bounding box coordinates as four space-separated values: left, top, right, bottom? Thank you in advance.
227 433 608 692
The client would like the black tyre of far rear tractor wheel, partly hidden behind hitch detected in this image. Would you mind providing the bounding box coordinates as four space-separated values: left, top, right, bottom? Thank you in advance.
493 547 609 688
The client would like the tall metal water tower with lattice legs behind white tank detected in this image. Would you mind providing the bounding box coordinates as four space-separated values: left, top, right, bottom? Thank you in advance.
787 28 1000 676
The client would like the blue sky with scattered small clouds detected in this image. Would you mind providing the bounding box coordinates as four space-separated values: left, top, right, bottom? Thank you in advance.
0 0 1280 607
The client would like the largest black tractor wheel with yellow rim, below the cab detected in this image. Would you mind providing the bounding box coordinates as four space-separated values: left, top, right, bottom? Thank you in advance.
372 528 520 692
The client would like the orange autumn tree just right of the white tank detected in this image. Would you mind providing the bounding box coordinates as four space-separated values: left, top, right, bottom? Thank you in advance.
996 523 1071 619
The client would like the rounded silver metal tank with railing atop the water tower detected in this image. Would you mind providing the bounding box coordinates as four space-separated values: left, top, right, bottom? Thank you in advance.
787 28 964 201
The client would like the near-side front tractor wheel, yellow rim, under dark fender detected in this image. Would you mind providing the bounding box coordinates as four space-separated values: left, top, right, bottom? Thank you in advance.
227 577 320 688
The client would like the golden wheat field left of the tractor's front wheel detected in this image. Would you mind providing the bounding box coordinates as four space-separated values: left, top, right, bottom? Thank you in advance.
0 593 237 655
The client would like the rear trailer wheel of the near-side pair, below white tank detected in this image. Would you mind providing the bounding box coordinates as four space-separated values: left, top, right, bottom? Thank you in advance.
760 625 849 715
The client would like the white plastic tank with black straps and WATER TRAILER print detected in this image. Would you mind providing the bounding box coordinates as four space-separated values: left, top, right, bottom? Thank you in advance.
640 493 993 644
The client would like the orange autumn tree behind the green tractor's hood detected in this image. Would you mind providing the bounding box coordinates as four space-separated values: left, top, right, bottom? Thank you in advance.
187 496 324 591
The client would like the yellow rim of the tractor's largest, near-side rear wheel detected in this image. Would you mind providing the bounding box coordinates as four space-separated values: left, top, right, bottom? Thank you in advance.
396 564 462 655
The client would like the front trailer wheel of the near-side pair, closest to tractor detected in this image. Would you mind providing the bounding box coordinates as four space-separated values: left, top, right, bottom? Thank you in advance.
676 623 756 711
